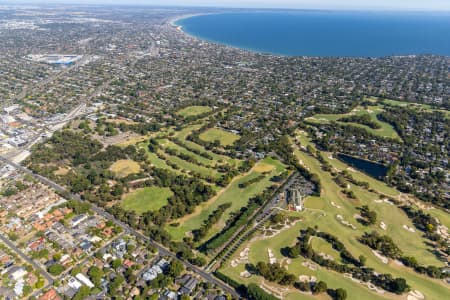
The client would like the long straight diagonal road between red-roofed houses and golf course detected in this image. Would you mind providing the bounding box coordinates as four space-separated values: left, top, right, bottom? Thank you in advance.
0 156 240 298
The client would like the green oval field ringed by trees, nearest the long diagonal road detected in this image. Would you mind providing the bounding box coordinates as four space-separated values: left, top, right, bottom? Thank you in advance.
121 187 173 214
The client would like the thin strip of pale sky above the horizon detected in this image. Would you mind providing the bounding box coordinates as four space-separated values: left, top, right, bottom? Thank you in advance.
5 0 450 11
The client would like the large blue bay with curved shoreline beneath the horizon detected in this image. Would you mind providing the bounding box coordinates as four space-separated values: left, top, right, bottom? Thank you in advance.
176 11 450 57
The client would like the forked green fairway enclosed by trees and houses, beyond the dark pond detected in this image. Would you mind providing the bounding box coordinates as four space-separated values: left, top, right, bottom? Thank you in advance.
306 106 400 139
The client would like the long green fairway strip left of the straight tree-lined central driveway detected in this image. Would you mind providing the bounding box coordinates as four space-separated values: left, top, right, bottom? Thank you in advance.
166 158 285 240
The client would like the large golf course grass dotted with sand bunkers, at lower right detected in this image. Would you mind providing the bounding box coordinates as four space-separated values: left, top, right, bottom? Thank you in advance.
221 136 450 300
